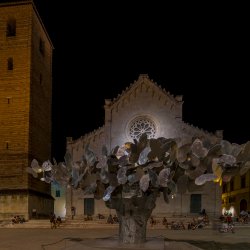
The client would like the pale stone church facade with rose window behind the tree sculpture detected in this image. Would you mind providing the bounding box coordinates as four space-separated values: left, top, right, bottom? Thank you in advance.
66 74 222 218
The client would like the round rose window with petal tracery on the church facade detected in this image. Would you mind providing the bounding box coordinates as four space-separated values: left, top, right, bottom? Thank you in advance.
129 117 156 140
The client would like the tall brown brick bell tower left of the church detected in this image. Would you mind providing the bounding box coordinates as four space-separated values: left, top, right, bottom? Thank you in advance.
0 0 54 219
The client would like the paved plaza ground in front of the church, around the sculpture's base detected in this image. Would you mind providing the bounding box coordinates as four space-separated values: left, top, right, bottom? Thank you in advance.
0 222 250 250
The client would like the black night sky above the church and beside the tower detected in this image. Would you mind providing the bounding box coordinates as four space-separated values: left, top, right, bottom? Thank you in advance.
31 0 250 160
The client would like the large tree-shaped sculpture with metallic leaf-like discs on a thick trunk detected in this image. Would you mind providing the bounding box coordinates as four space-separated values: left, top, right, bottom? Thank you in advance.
28 134 250 243
